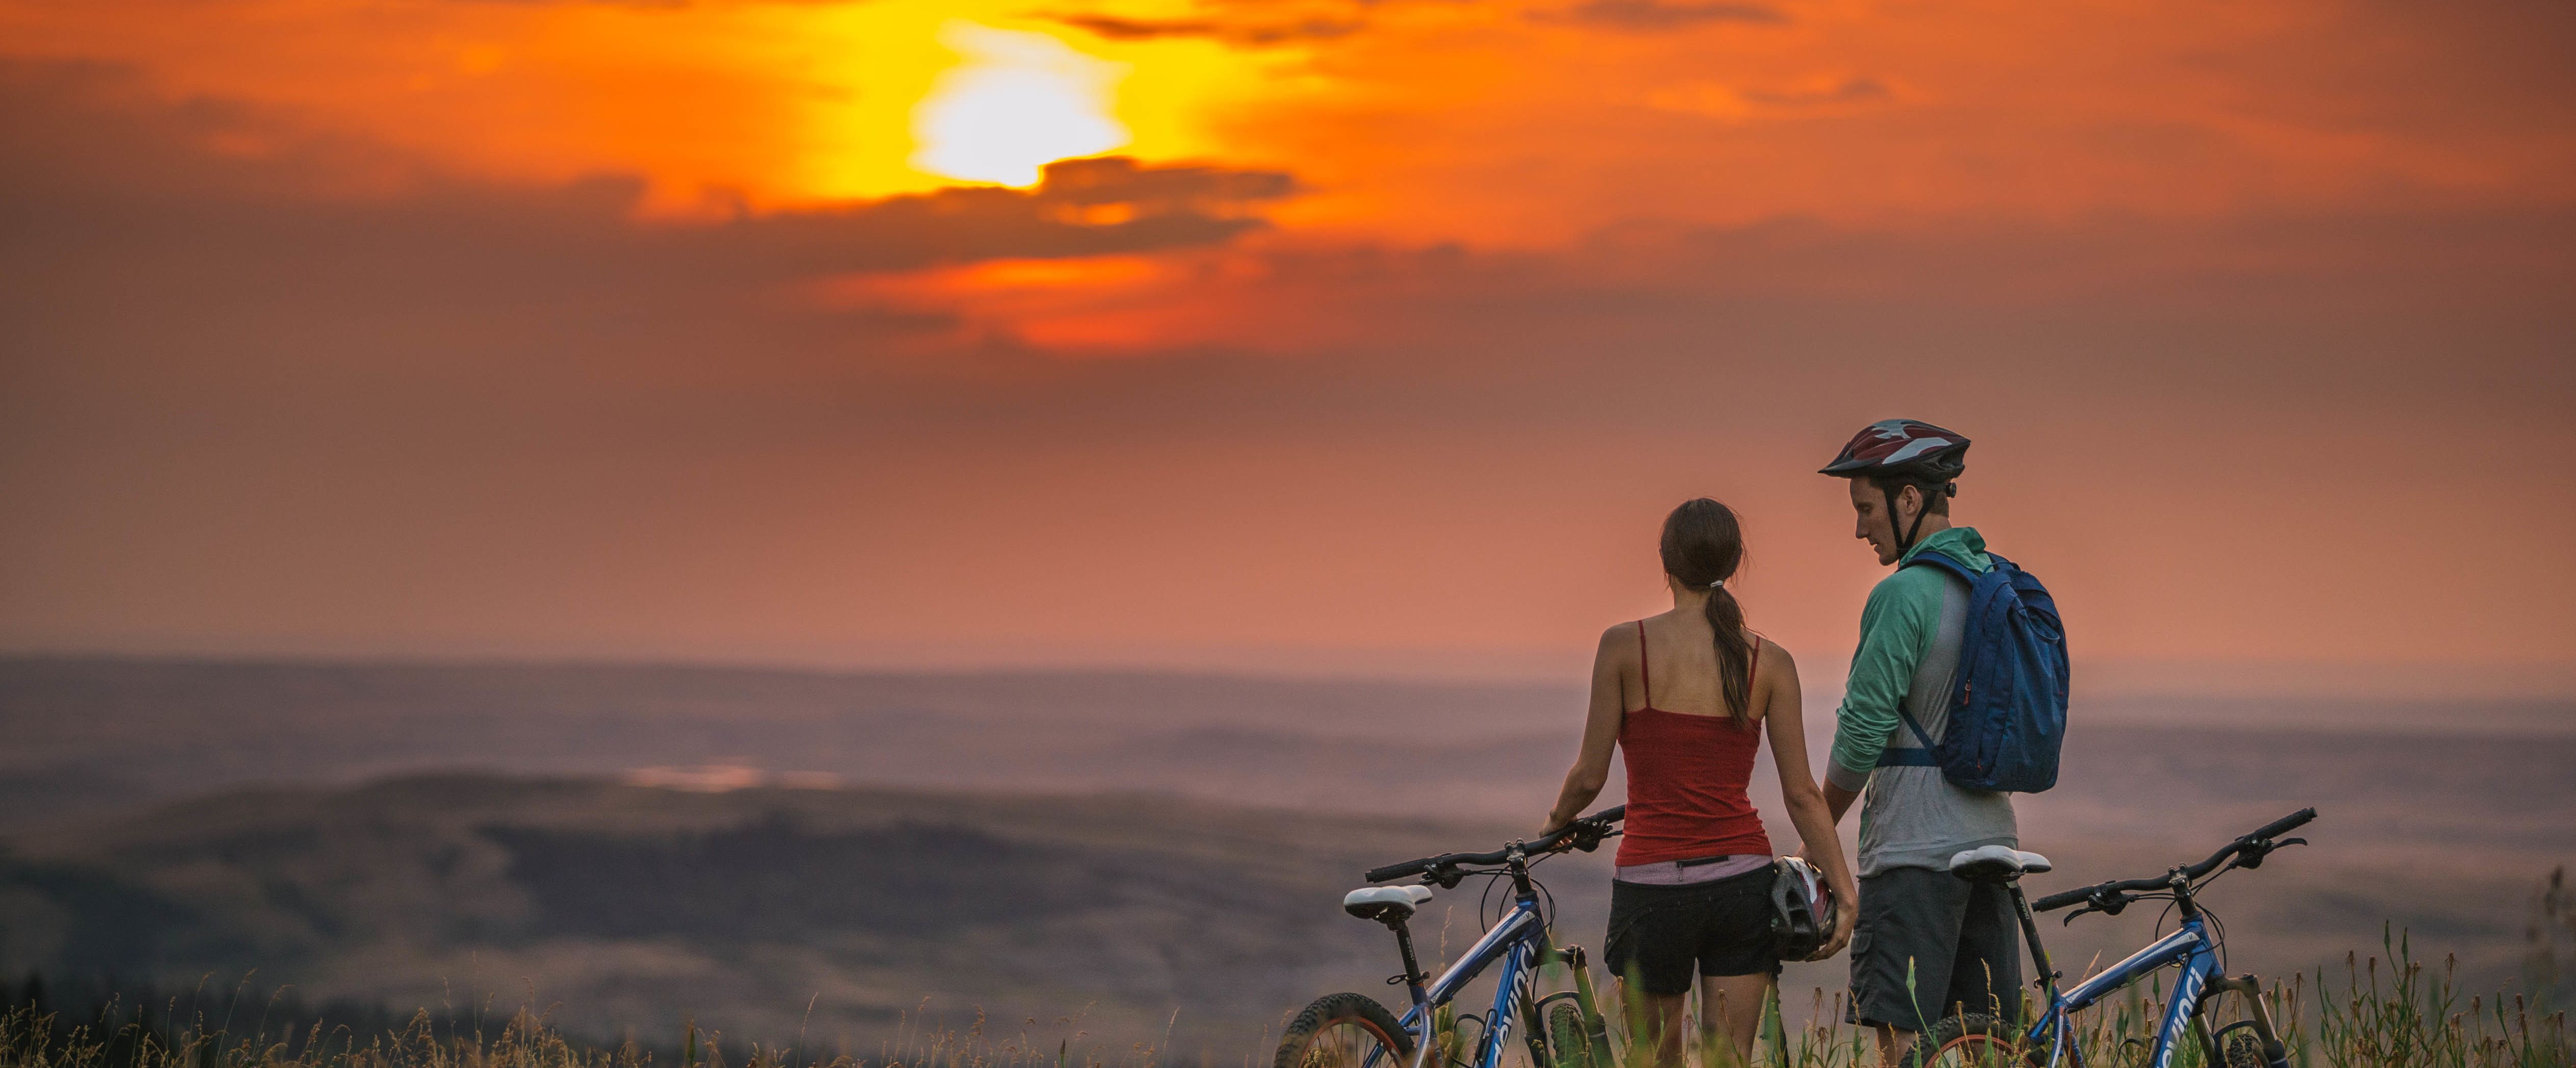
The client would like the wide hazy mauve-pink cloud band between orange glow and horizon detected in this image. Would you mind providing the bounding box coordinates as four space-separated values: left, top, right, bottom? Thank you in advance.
0 67 2576 663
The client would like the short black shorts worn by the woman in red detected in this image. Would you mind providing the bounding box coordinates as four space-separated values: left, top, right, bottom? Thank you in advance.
1602 864 1780 996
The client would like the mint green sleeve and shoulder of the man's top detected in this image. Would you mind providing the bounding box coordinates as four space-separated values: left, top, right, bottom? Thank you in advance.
1824 526 1994 792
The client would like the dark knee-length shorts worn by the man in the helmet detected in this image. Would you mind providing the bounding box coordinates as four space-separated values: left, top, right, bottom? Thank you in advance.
1845 867 2022 1032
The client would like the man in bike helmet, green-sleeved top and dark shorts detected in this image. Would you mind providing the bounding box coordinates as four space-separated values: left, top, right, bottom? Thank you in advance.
1821 418 2022 1065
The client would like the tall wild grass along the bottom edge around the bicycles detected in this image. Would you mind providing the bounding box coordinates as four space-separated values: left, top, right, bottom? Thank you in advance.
0 934 2576 1068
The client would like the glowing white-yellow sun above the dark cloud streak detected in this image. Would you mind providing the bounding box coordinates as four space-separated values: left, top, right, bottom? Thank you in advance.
912 20 1128 186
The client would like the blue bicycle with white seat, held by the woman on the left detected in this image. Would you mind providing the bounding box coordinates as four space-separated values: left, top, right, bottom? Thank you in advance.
1275 805 1628 1068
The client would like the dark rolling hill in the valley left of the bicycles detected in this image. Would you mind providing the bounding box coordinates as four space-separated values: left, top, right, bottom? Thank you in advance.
0 777 1546 1053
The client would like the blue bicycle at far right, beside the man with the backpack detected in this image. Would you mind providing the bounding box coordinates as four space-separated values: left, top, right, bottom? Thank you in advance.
1911 807 2316 1068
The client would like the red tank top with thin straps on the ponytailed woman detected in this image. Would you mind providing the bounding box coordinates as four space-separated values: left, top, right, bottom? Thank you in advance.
1618 619 1770 867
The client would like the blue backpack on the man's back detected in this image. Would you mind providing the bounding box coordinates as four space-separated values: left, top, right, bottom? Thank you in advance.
1896 552 2066 794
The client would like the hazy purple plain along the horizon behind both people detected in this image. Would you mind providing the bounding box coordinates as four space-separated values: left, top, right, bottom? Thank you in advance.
0 658 2576 849
